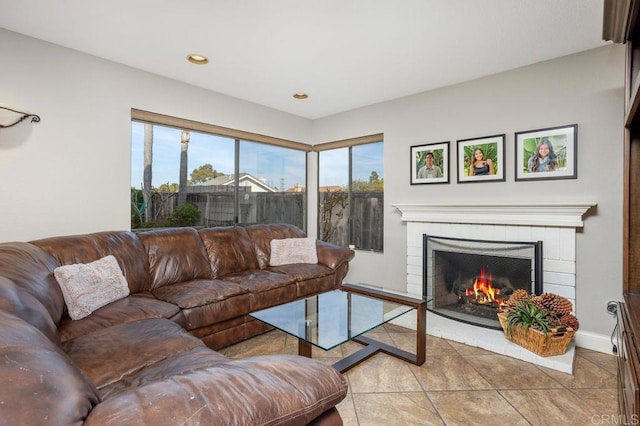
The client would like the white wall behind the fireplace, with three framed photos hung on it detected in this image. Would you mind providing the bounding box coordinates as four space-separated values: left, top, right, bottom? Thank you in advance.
312 45 624 337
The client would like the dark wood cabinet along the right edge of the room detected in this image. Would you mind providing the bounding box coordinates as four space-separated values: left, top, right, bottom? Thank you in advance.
602 0 640 424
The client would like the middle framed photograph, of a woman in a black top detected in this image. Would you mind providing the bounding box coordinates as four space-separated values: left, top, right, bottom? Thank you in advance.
458 134 504 183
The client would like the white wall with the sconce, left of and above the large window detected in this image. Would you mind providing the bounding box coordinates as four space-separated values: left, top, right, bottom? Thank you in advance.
0 29 311 241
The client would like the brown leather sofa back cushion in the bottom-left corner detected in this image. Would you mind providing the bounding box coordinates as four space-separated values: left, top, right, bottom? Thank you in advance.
0 311 99 425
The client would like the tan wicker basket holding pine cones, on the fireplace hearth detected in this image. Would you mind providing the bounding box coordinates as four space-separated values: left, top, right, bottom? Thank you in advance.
498 312 575 356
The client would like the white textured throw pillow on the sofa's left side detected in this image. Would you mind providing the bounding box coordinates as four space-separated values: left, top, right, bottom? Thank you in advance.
53 255 129 320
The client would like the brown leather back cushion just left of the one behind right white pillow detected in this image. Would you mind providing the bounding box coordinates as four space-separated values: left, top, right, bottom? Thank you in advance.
199 226 259 278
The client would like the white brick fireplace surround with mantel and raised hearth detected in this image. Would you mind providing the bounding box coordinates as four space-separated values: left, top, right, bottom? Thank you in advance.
394 201 596 373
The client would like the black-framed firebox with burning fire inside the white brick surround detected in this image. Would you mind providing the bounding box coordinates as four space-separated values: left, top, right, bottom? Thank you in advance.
423 234 542 330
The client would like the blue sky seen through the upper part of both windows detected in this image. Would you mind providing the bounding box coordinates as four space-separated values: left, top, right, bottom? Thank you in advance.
131 121 383 190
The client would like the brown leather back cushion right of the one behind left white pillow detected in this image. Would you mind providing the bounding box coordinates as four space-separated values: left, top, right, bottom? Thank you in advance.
138 228 212 289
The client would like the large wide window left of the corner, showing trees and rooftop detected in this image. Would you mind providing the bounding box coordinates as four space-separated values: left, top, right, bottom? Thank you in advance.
131 110 310 229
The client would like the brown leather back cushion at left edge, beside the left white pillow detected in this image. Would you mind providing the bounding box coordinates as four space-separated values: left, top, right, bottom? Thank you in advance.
0 242 65 328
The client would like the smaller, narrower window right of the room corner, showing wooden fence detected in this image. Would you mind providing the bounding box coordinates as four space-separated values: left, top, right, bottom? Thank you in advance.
314 135 384 252
